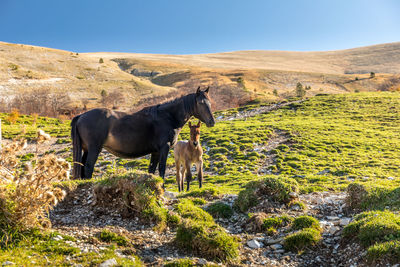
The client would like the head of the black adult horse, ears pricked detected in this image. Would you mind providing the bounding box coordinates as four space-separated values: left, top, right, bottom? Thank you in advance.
194 86 215 127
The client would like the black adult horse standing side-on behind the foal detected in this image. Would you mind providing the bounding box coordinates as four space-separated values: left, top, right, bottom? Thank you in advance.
71 87 215 185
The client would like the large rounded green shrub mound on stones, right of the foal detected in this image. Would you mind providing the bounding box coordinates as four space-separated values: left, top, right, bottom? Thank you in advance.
234 177 299 212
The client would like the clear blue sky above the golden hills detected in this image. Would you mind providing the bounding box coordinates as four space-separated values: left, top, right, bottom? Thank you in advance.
0 0 400 54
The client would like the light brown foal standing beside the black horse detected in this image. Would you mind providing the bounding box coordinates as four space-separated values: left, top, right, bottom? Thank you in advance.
174 121 203 192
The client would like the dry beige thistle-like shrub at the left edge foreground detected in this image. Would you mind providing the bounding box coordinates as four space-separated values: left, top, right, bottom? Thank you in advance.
0 136 70 228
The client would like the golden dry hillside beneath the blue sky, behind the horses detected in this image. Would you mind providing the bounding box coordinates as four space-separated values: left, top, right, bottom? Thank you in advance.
0 42 400 113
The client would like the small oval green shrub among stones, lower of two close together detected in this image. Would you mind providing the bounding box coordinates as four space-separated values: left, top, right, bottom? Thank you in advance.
283 228 321 252
